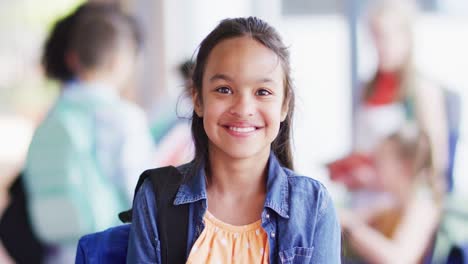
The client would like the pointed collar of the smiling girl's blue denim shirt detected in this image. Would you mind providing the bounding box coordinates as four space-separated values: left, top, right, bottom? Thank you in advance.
174 152 289 218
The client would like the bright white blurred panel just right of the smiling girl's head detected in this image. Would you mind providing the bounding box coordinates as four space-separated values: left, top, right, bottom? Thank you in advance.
279 15 351 194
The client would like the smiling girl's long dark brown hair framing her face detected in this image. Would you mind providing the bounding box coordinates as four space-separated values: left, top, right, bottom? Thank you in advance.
192 17 294 169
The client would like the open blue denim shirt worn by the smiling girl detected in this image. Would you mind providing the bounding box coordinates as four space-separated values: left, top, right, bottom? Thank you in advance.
127 154 341 263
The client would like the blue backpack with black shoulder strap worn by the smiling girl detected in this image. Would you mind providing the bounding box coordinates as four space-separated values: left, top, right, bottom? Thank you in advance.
75 166 189 264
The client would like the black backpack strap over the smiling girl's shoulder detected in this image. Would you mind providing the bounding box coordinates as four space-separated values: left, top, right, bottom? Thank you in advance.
119 166 189 264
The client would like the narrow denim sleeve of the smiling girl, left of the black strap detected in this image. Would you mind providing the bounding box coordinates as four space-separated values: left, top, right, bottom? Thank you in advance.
127 180 161 263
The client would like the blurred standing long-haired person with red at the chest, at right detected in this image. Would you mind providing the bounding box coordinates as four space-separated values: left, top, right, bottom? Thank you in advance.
331 0 449 194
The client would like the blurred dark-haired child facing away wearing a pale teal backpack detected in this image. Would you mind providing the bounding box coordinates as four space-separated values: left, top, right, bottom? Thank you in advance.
25 3 154 263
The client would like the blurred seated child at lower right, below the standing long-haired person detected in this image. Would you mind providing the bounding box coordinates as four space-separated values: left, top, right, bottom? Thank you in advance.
340 125 444 263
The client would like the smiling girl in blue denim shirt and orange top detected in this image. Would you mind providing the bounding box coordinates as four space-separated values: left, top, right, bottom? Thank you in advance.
127 17 340 263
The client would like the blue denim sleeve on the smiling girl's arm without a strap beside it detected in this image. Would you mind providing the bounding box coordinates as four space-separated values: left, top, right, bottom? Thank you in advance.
310 191 341 264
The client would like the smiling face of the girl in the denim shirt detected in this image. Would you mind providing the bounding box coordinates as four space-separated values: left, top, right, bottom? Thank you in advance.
194 37 287 162
